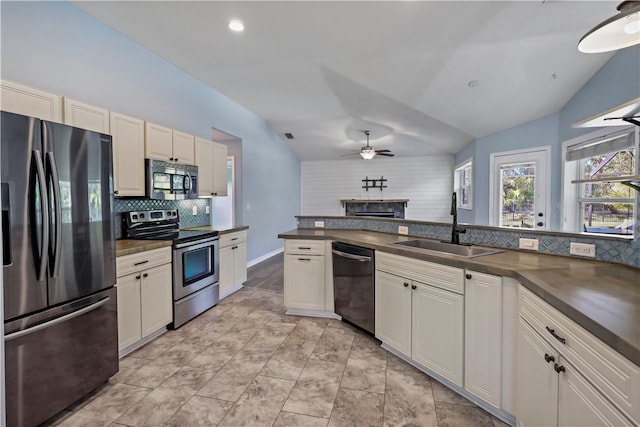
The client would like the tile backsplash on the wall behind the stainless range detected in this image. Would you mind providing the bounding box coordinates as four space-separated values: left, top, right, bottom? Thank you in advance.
113 198 211 239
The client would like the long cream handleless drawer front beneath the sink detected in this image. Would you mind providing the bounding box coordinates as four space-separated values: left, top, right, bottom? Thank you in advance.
376 251 464 294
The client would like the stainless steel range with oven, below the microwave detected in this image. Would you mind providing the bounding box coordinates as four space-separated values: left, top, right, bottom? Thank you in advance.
122 209 220 328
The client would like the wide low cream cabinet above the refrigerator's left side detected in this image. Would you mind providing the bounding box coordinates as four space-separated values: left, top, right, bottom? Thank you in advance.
0 80 62 123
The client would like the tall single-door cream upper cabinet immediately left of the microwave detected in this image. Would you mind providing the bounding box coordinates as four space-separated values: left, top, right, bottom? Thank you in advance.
110 112 145 196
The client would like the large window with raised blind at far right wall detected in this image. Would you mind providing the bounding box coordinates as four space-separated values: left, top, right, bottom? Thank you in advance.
565 129 638 236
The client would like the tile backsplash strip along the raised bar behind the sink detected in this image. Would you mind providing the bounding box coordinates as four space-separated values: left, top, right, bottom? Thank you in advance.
297 216 640 268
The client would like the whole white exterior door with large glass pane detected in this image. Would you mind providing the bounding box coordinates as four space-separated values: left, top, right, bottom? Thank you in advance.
489 147 550 230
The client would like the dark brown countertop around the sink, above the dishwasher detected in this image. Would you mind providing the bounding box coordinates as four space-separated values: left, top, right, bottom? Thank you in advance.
278 229 640 366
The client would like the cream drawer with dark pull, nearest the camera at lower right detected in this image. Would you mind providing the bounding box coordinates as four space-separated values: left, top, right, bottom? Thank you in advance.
519 286 640 423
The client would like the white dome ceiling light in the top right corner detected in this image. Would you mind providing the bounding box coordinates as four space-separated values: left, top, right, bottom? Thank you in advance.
578 1 640 53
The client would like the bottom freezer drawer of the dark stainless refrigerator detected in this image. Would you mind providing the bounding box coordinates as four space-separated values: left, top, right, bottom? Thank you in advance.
5 288 118 426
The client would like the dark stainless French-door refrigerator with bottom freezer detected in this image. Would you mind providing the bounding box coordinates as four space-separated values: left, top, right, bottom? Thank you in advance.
0 111 118 426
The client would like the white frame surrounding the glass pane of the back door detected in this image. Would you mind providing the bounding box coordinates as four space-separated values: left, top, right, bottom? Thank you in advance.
489 145 551 230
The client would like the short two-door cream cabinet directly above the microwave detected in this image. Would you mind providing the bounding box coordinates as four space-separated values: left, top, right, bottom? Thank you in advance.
145 122 195 165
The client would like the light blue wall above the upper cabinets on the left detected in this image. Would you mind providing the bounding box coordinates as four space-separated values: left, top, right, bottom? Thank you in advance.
0 2 300 260
